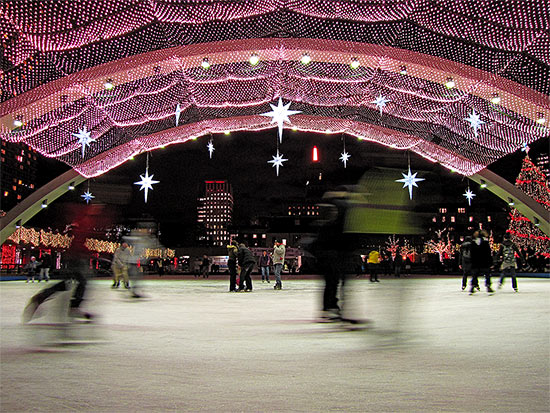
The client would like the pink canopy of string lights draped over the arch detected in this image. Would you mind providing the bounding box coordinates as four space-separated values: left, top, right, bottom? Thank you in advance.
0 0 550 177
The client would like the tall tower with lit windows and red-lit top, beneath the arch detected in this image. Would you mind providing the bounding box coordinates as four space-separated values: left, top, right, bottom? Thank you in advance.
197 181 233 246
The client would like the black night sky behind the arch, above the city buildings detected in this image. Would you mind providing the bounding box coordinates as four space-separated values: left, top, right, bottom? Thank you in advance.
29 132 548 246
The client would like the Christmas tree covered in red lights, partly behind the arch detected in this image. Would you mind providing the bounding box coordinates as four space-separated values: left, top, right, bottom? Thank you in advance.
507 155 550 255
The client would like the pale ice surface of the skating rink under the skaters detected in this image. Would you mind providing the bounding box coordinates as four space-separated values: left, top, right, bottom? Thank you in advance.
0 278 550 412
